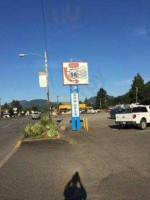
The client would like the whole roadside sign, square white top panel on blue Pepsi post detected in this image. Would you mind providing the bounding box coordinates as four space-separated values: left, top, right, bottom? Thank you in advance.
63 62 88 131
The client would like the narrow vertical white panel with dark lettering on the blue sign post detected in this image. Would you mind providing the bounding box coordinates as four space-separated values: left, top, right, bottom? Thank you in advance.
71 93 80 117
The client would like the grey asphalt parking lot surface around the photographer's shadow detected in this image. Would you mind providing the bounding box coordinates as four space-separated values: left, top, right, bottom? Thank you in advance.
0 113 150 200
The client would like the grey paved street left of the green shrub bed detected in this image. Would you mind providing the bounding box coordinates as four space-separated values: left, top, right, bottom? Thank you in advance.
0 117 31 161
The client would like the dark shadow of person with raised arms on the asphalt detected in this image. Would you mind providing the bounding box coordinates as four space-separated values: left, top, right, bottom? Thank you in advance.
64 172 87 200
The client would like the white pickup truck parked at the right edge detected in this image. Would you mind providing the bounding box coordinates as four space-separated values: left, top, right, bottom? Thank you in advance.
116 105 150 130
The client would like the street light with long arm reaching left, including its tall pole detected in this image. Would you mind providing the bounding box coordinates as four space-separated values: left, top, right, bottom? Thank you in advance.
19 51 50 117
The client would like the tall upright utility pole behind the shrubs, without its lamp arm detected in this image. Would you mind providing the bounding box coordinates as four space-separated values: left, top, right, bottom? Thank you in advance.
44 51 51 118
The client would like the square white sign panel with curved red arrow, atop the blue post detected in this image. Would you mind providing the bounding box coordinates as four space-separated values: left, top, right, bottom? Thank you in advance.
63 62 89 85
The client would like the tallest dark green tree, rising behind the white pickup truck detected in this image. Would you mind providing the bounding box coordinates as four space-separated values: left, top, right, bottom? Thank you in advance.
129 73 145 103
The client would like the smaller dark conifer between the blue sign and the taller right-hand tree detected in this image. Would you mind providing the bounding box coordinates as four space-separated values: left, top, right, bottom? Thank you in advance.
95 88 108 109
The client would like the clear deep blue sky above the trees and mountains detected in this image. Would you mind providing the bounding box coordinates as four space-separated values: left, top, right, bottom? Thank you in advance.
0 0 150 103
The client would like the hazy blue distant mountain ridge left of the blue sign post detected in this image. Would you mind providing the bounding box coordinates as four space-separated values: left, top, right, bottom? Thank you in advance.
20 99 57 108
